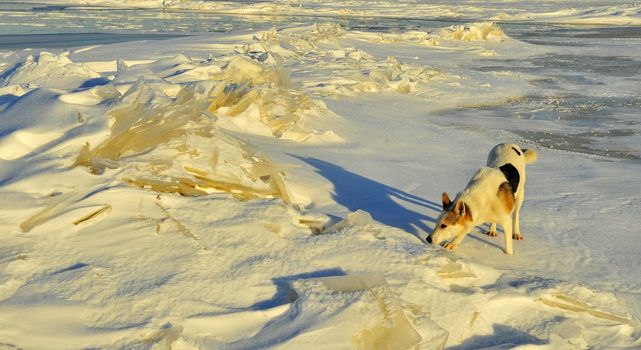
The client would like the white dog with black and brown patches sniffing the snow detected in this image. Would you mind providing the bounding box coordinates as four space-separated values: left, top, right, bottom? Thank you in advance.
427 143 538 255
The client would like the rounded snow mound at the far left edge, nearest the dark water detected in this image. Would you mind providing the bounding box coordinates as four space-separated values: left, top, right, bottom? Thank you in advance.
0 51 100 89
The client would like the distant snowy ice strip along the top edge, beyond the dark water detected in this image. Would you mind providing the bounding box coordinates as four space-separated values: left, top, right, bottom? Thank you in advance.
13 0 641 25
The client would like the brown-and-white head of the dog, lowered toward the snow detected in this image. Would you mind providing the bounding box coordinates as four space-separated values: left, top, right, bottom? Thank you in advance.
427 192 472 245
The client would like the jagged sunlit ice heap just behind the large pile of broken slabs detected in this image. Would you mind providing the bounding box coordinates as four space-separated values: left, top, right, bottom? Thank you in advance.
107 50 342 142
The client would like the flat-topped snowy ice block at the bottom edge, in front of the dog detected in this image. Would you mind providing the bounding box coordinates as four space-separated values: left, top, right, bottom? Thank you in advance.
215 274 440 350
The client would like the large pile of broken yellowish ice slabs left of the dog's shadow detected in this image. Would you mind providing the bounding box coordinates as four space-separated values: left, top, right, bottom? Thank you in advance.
74 80 291 203
